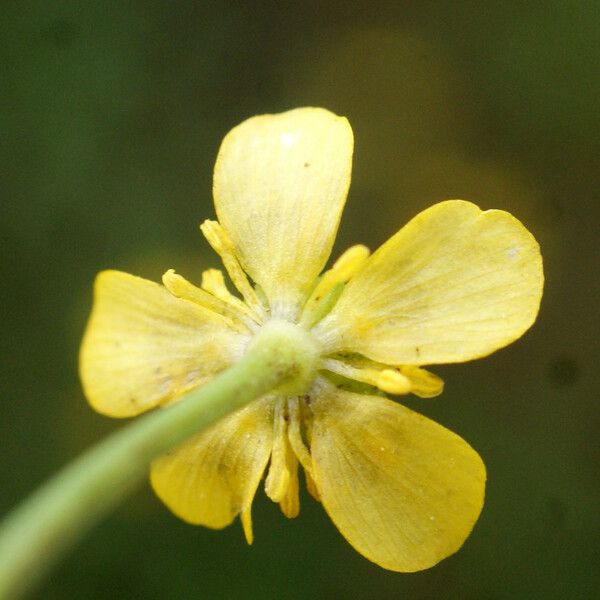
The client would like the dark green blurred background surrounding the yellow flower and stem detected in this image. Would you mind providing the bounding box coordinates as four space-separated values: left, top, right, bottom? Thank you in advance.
0 0 600 600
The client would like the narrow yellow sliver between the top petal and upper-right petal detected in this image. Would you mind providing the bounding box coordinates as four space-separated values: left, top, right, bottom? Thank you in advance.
300 244 369 328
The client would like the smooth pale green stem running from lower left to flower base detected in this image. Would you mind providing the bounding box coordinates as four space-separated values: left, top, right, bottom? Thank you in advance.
0 327 306 600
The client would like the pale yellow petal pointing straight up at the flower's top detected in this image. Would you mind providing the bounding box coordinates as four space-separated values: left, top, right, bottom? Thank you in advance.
214 108 353 318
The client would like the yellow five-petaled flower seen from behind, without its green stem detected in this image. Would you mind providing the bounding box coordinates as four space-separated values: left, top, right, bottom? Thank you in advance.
81 108 543 571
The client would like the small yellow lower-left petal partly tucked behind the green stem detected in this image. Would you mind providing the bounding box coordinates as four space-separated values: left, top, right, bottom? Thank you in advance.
150 398 273 543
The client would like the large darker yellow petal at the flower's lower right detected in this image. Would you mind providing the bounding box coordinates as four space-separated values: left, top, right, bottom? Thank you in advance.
311 384 485 572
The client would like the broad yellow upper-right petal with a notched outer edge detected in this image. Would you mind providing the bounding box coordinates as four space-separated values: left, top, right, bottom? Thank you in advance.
315 200 544 365
